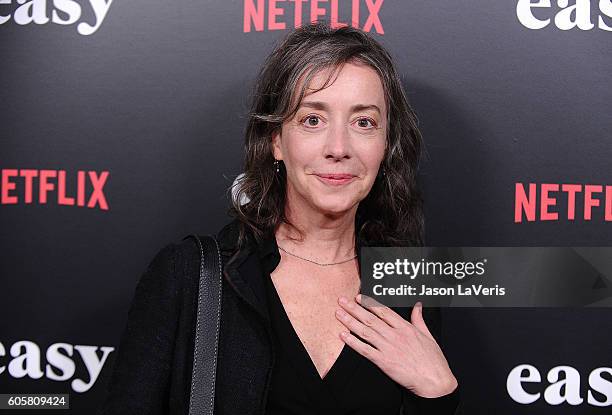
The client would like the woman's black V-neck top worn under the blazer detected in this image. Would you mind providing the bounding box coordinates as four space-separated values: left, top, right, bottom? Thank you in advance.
259 232 457 415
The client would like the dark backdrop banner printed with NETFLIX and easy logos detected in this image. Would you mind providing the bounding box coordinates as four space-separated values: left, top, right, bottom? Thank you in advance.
0 0 612 415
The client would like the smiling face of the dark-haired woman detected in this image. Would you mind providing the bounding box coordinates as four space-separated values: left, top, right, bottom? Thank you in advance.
272 63 387 215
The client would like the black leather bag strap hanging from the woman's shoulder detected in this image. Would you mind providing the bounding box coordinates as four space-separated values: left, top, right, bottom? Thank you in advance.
183 234 222 415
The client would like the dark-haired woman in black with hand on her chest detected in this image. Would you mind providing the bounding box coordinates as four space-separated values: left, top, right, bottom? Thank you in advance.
101 23 459 415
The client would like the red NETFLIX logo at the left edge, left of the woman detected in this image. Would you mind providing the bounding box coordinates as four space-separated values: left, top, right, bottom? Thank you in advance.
0 169 109 210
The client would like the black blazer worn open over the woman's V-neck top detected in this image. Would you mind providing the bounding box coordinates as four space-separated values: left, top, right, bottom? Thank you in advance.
98 220 459 415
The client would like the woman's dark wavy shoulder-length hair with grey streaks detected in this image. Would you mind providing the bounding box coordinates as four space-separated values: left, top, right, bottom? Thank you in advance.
228 22 424 250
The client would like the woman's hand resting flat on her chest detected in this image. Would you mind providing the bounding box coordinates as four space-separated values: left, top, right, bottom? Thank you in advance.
336 294 457 398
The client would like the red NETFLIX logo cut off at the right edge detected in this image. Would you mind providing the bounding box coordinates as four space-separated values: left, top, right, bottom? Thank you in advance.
514 183 612 223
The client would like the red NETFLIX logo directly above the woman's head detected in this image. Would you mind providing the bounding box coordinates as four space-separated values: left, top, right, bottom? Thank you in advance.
243 0 385 35
